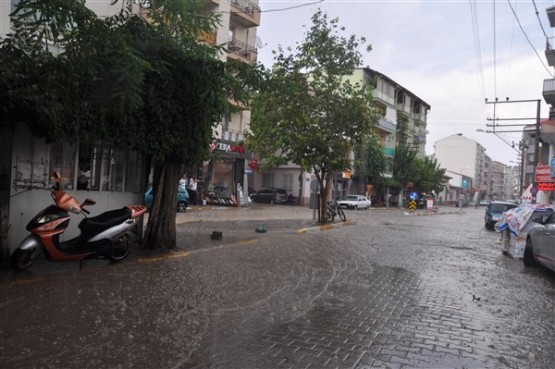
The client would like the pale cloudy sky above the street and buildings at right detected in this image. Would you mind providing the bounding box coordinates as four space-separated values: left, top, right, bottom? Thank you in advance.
257 0 555 165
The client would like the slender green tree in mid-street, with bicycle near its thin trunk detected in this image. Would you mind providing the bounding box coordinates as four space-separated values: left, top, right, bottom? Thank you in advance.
247 11 377 221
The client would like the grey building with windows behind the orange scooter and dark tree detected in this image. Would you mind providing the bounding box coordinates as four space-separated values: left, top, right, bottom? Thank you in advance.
0 0 147 260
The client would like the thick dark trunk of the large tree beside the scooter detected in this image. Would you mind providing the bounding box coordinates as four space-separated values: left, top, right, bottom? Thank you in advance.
143 161 181 250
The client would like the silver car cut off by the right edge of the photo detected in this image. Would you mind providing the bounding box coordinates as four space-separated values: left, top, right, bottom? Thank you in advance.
523 211 555 272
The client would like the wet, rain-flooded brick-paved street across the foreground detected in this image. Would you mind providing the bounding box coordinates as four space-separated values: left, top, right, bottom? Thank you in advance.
0 206 555 369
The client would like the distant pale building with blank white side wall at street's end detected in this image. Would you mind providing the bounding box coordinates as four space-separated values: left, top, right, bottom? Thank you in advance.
434 133 492 201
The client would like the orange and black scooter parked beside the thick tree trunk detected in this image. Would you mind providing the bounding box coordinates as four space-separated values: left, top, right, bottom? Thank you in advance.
10 172 146 270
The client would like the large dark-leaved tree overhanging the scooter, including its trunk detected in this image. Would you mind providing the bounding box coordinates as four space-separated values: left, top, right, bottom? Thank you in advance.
0 0 249 249
